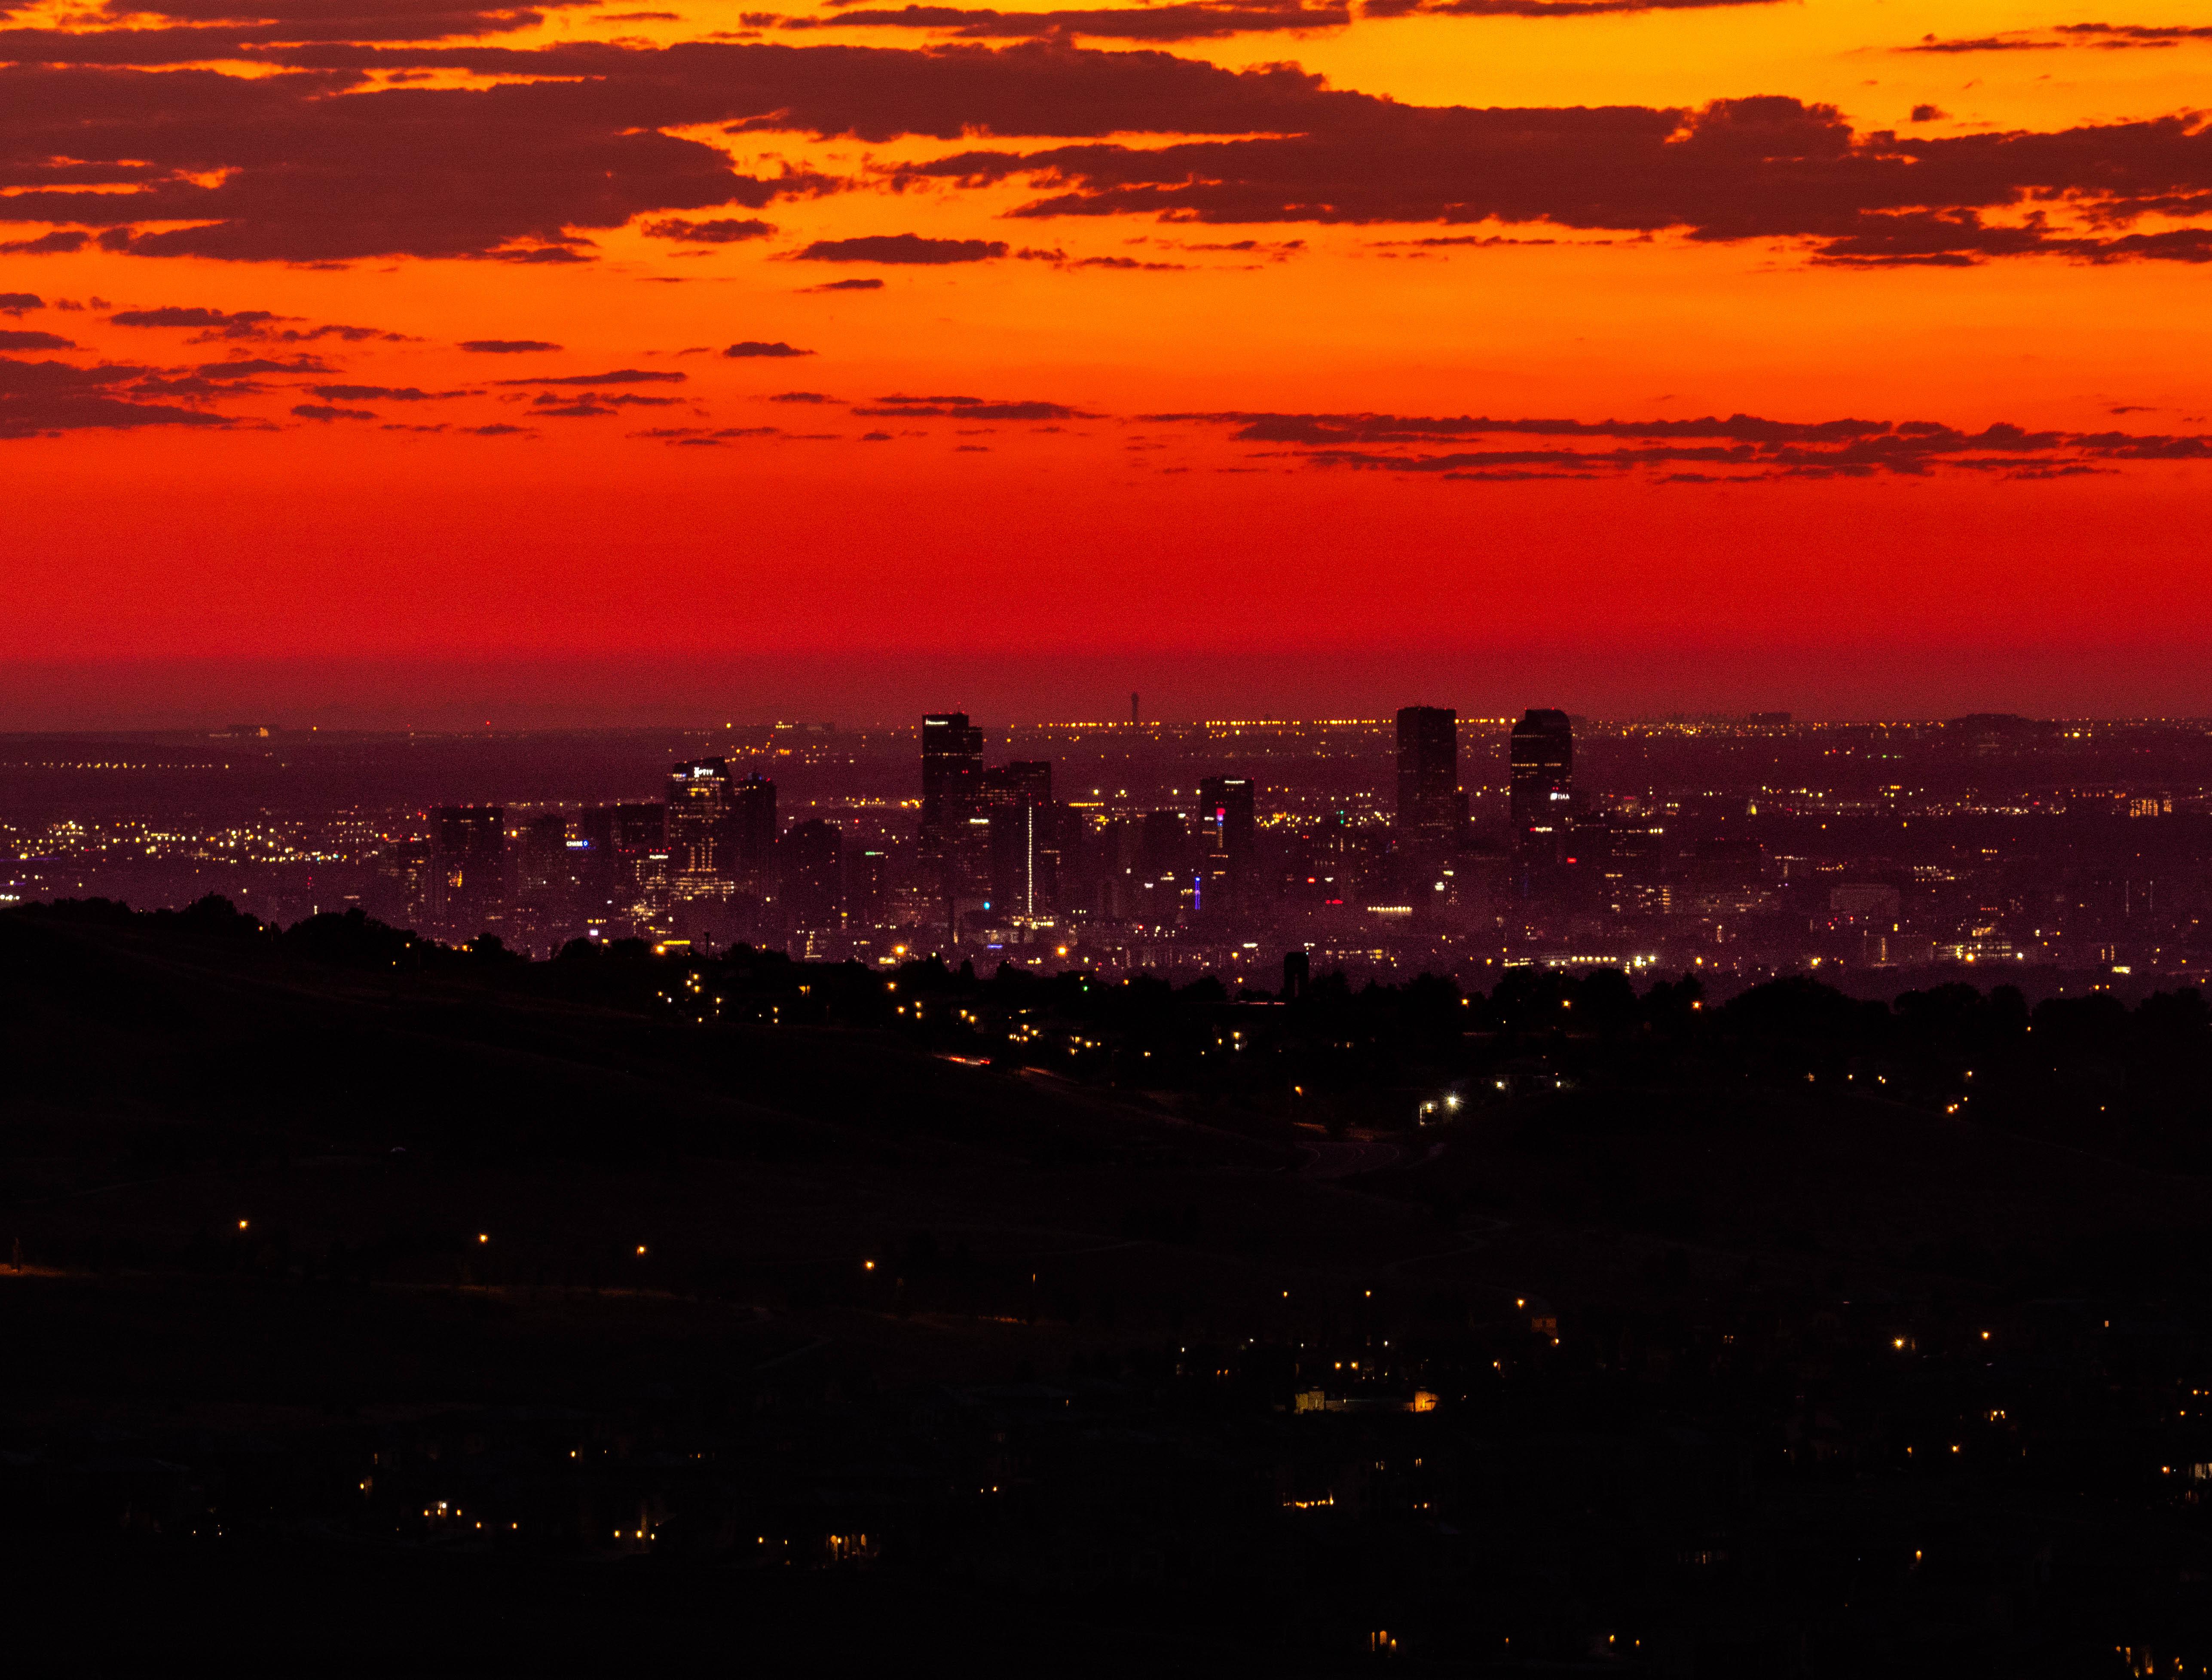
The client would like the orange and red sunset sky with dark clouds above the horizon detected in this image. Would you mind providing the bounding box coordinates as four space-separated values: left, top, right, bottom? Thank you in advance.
0 0 2212 728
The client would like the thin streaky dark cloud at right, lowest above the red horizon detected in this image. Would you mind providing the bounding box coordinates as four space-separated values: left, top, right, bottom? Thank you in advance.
1137 412 2212 483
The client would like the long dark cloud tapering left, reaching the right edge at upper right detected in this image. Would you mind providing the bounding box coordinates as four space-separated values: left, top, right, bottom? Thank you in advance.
905 98 2212 261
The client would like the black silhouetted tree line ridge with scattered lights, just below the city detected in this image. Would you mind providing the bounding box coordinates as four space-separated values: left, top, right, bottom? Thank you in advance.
6 897 2212 1171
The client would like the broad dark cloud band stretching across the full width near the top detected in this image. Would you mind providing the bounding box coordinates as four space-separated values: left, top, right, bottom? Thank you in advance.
0 43 2212 269
